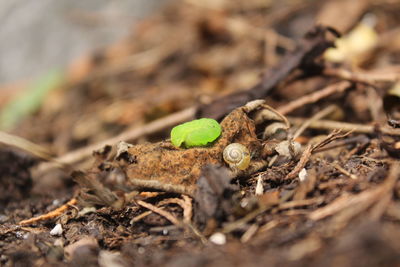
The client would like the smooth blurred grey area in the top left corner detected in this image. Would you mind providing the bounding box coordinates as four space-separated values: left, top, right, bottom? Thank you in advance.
0 0 166 84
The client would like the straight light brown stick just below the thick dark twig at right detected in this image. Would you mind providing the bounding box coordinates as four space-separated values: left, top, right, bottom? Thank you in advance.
277 81 351 115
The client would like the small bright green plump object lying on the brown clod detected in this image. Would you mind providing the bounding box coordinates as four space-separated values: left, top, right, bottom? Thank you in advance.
171 118 222 148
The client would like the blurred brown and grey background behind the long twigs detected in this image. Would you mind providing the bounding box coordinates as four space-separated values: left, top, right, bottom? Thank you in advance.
0 0 400 155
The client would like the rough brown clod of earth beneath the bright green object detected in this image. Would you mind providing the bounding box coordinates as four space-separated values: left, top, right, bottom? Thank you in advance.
92 100 278 195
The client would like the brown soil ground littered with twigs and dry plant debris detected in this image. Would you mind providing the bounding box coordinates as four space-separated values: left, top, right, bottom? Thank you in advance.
0 0 400 266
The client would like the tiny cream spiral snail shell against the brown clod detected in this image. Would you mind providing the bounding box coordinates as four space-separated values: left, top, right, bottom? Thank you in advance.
223 143 250 170
